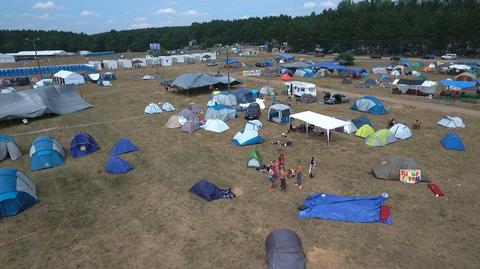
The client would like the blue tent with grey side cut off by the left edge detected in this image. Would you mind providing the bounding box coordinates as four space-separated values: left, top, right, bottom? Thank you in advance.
0 168 38 217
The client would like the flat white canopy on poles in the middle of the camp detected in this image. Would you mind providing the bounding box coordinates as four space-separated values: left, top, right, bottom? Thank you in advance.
290 111 350 143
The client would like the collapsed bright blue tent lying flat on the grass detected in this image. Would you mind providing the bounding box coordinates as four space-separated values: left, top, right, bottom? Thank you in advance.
298 193 392 224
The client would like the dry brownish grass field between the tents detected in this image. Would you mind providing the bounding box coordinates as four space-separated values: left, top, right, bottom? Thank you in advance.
0 53 480 268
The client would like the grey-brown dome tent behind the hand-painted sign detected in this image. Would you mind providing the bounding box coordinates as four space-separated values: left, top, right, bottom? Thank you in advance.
373 155 427 180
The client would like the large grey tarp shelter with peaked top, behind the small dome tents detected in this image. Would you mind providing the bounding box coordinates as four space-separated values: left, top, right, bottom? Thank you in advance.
171 73 240 90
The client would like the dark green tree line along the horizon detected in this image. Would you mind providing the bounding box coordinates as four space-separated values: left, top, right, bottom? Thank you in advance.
0 0 480 55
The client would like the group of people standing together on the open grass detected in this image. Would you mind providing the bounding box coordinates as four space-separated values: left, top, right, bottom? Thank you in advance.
267 153 316 192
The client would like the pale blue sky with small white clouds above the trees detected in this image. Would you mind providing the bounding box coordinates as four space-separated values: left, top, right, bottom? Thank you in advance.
0 0 340 34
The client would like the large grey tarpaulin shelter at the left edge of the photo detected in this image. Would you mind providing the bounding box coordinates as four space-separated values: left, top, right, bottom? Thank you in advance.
0 85 92 120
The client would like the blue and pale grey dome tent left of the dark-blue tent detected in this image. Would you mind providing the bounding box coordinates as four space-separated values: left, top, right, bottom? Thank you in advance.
30 136 65 171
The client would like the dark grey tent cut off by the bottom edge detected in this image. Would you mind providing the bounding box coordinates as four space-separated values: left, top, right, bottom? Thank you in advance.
265 229 307 269
